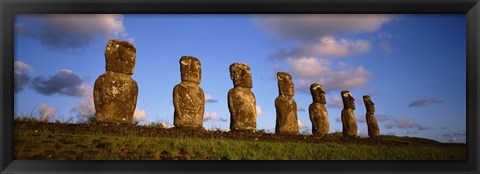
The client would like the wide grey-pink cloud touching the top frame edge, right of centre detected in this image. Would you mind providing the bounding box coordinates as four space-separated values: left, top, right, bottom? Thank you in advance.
255 14 396 40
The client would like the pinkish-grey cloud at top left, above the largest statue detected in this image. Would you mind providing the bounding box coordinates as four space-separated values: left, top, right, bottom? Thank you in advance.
16 14 133 50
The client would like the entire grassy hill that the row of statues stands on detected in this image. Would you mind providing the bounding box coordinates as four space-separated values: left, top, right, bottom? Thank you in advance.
14 120 466 160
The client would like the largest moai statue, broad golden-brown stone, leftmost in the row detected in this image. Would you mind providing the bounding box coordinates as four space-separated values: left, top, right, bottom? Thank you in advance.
93 40 138 123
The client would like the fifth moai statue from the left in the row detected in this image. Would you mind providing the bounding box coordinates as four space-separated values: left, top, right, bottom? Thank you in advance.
308 83 330 135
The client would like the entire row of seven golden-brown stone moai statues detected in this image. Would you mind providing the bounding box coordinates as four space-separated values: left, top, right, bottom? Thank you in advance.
93 40 379 137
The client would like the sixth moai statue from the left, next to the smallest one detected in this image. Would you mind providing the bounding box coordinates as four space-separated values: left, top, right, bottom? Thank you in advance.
341 91 358 137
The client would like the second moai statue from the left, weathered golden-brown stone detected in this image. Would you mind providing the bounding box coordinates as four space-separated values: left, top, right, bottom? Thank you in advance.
173 56 205 129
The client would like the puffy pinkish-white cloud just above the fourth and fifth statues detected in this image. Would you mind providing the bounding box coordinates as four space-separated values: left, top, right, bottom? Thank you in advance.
288 58 372 93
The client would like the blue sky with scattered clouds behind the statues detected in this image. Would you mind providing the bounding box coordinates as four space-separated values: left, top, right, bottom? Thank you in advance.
15 14 466 142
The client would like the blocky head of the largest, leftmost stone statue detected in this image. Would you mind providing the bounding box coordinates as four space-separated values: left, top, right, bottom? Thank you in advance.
105 40 136 75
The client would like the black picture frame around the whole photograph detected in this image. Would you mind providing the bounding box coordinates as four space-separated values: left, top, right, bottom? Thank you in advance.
0 0 480 174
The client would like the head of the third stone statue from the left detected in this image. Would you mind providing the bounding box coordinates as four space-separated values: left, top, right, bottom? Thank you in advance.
230 63 253 88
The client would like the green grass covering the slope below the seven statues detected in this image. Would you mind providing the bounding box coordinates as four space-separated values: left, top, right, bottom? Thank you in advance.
14 122 466 160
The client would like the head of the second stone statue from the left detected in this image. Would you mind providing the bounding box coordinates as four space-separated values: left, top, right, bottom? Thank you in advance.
180 56 202 83
